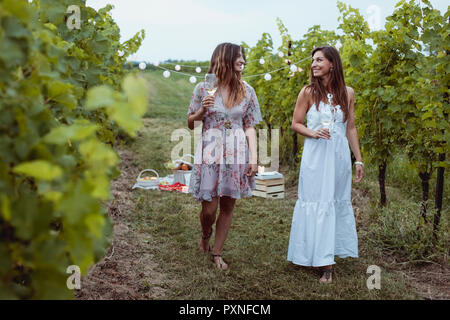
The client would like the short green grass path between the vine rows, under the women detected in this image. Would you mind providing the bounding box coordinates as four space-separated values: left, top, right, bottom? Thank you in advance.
119 72 446 300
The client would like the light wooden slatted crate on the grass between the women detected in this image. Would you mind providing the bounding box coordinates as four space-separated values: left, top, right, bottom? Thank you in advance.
252 171 284 199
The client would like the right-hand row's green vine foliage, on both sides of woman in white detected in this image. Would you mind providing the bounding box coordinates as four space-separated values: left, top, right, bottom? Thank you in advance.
243 1 450 188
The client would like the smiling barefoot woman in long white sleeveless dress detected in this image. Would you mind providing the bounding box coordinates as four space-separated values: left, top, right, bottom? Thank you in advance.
287 47 364 283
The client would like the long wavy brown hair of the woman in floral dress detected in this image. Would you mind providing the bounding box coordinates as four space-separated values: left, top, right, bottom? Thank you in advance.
208 42 246 108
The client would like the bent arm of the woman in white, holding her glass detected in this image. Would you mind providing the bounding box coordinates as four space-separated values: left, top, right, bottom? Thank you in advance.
291 87 330 139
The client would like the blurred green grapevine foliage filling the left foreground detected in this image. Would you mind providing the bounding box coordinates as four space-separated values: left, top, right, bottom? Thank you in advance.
0 0 147 299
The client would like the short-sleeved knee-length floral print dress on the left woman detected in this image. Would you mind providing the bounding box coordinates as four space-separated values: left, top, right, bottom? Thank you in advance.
188 82 262 201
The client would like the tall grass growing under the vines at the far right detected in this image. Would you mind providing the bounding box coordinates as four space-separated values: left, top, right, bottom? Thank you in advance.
363 154 450 263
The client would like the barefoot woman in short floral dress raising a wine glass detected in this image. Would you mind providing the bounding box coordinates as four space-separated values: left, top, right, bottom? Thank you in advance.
188 43 262 270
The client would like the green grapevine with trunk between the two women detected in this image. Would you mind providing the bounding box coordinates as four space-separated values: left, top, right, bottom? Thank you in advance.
243 19 337 164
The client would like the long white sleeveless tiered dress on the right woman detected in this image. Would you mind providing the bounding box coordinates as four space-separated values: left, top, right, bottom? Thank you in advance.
287 102 358 267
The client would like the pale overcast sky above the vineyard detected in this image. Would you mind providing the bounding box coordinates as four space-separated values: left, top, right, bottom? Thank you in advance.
86 0 449 63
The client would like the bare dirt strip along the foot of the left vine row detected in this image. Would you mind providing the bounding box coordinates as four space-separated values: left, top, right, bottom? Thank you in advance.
75 150 165 300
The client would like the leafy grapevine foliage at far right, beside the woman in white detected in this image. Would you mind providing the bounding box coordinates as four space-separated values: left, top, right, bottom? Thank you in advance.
358 1 448 172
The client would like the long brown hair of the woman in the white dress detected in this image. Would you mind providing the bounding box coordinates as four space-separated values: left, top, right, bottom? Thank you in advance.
307 46 348 122
